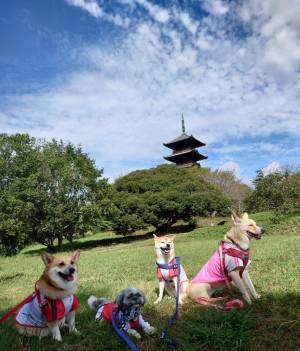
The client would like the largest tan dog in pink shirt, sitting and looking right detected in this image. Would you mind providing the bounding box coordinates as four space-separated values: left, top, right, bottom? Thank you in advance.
188 212 263 304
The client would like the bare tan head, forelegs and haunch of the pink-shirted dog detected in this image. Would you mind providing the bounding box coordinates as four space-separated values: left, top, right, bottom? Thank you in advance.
187 212 262 304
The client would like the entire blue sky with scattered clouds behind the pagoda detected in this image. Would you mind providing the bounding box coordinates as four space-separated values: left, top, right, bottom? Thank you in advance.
0 0 300 182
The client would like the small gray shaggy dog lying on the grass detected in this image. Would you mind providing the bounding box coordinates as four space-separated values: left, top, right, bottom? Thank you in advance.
88 288 156 339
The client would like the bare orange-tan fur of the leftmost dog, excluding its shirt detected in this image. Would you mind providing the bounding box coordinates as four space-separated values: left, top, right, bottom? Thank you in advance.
16 250 80 341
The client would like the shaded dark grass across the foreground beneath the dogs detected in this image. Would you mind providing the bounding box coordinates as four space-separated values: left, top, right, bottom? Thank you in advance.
0 291 300 351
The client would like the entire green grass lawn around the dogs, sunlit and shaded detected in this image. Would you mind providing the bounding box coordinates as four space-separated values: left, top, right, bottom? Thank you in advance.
0 213 300 351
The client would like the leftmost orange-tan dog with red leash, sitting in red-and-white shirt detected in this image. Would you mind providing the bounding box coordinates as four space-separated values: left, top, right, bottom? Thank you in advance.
16 250 80 341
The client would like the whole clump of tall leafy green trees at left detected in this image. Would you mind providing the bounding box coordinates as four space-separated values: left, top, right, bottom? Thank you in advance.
0 135 111 254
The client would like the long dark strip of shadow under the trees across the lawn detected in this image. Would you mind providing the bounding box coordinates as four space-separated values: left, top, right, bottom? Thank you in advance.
23 224 193 255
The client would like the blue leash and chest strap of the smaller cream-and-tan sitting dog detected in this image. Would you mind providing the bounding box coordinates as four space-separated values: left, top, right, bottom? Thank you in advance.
157 256 180 349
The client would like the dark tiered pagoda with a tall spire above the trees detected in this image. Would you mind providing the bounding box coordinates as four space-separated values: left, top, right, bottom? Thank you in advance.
164 115 207 167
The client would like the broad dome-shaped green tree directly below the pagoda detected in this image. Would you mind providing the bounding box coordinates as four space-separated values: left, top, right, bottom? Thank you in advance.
112 165 230 234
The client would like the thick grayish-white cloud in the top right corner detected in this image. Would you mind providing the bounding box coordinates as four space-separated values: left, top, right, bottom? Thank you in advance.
240 0 300 79
